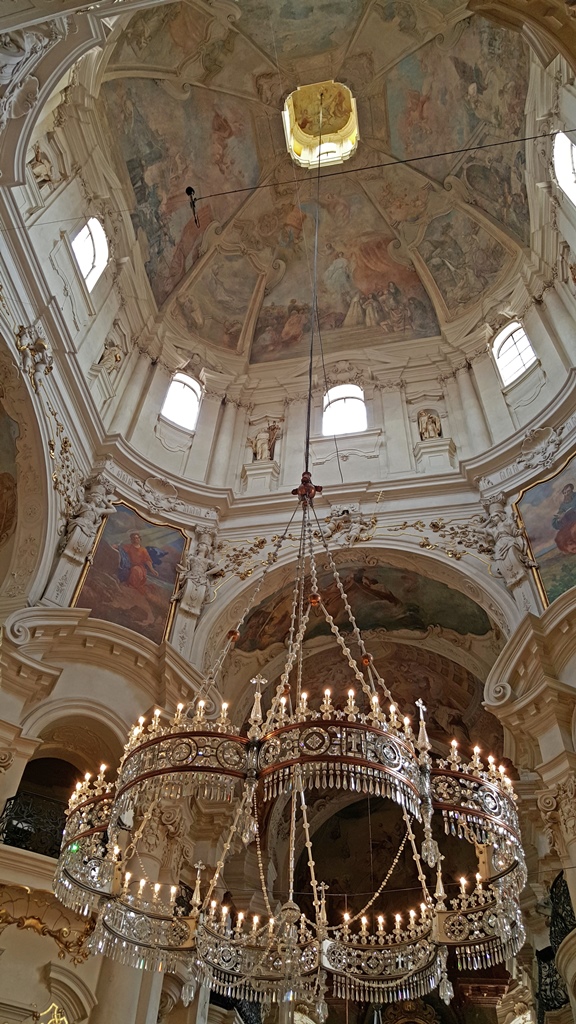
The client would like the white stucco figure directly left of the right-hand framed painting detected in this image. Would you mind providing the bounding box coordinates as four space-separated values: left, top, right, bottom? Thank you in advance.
480 495 538 589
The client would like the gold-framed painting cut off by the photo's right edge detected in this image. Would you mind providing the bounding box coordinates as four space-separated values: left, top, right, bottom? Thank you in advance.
515 456 576 604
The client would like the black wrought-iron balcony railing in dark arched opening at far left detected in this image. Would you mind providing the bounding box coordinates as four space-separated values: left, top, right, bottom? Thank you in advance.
0 791 66 857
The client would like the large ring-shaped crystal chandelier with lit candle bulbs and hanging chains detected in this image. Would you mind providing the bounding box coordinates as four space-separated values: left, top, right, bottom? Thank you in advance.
55 485 526 1022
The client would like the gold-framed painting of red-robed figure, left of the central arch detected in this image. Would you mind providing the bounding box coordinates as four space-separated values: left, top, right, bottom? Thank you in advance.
72 502 187 643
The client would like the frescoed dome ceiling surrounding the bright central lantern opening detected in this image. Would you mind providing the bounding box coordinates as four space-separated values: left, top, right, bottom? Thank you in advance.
100 0 530 364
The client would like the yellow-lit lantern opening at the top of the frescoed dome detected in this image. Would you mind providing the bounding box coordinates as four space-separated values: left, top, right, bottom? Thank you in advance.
282 81 360 169
